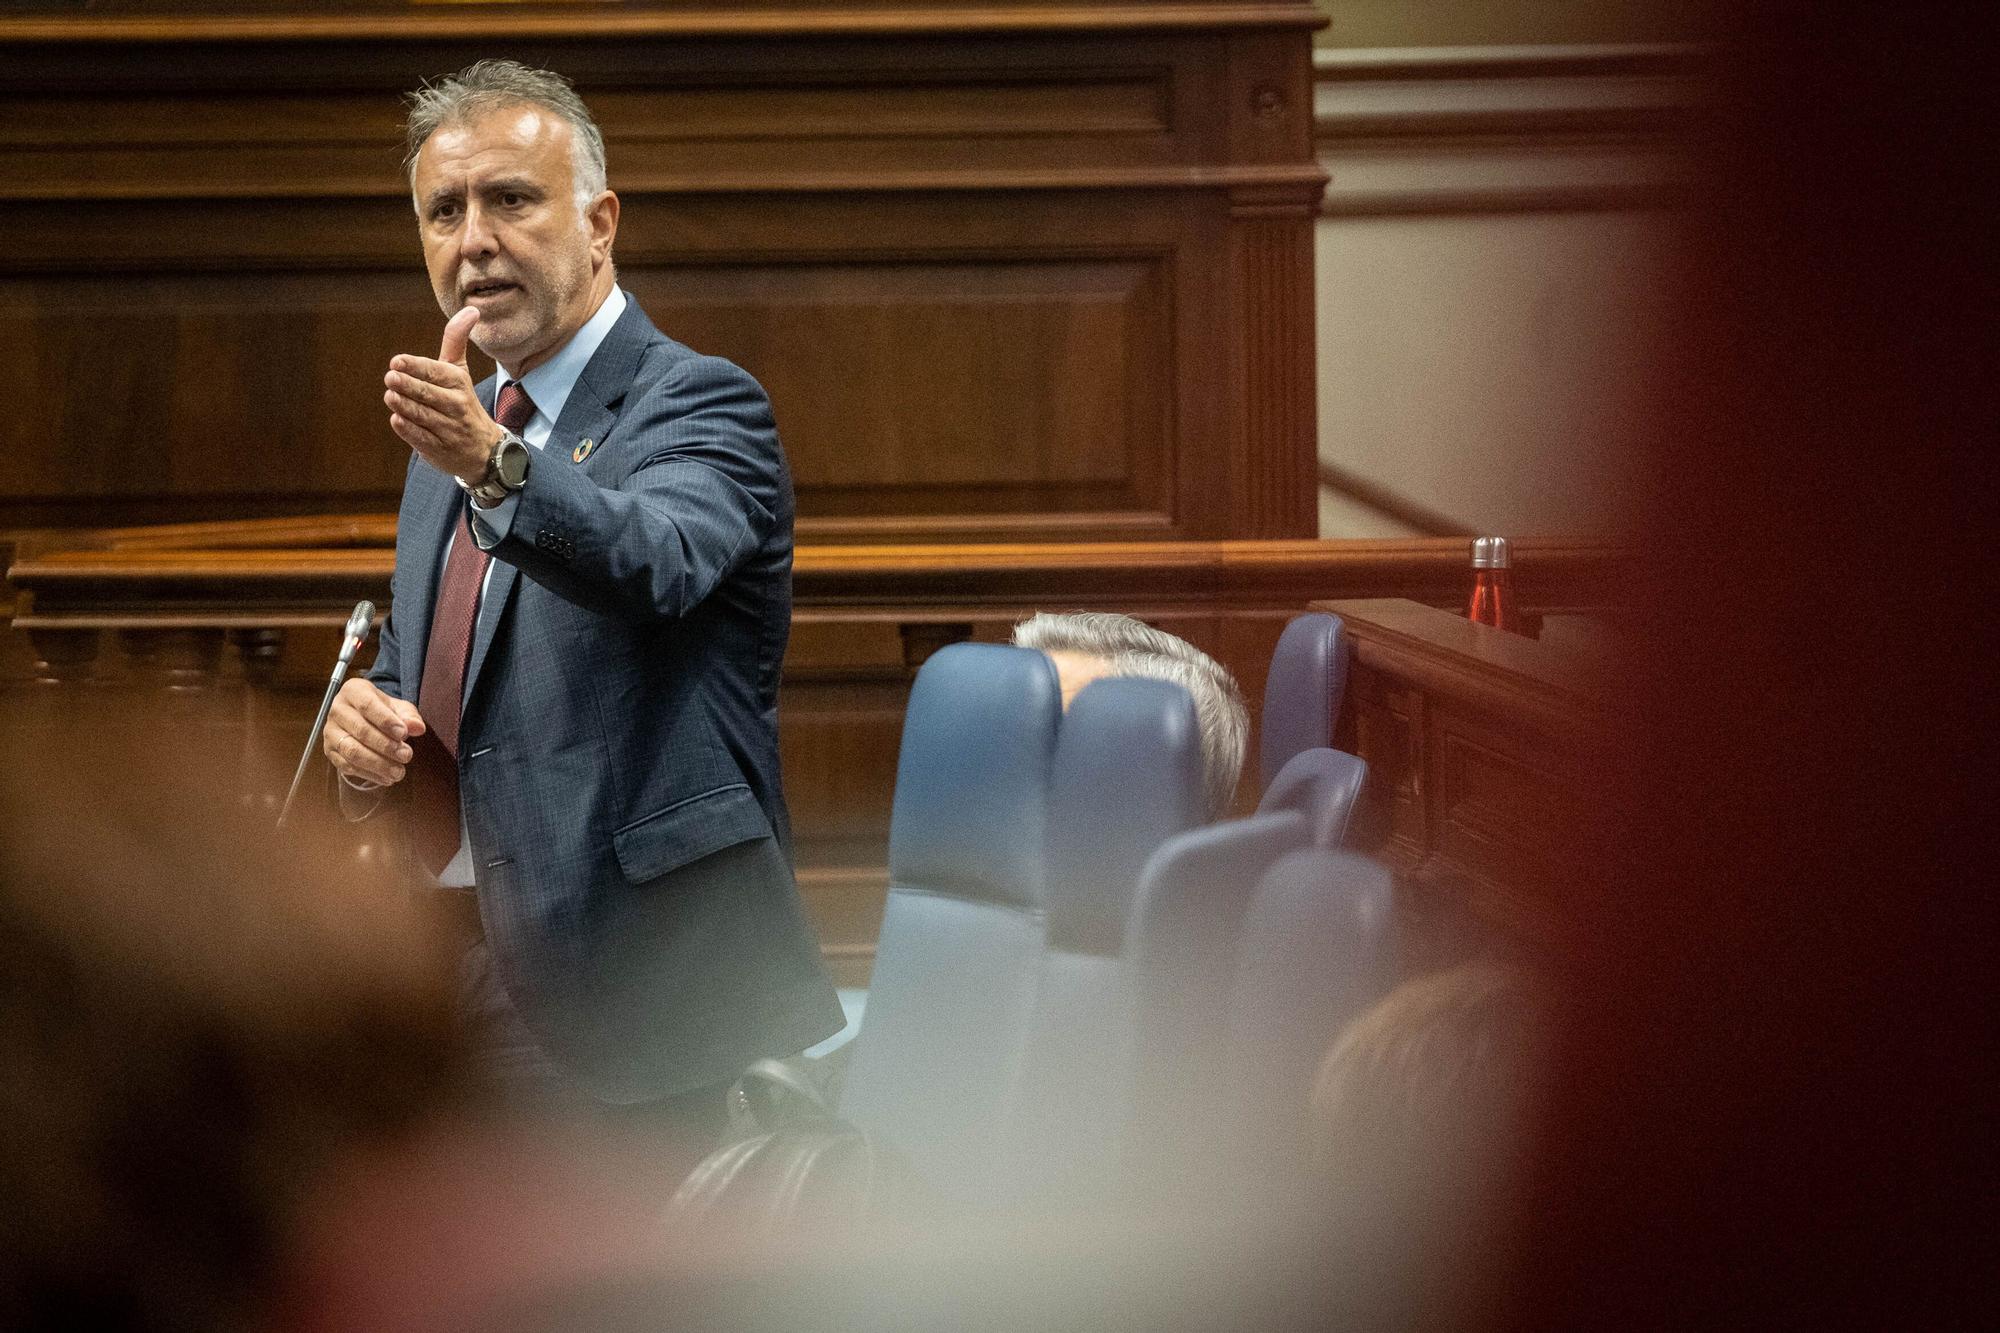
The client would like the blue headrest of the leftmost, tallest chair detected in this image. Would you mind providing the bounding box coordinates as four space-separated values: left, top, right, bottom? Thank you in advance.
888 642 1062 907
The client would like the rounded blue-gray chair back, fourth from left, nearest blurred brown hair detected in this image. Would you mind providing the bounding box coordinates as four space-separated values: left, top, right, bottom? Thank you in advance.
1218 849 1400 1201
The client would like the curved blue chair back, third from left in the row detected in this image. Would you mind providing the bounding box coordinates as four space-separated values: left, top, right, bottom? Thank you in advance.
1124 811 1308 1193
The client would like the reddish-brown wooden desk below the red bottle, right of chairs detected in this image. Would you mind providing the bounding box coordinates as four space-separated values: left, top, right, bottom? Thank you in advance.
1312 598 1624 945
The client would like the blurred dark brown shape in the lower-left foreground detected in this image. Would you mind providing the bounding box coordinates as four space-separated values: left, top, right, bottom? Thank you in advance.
0 715 464 1329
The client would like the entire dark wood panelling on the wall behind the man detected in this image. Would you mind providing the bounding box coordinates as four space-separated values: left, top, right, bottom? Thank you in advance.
0 2 1324 540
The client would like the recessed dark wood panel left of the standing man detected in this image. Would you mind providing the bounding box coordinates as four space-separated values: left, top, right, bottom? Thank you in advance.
0 268 438 524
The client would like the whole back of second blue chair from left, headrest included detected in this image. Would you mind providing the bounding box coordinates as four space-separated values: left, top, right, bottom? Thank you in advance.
1000 679 1206 1205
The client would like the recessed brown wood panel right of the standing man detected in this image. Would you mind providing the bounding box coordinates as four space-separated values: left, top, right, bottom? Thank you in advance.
628 258 1170 522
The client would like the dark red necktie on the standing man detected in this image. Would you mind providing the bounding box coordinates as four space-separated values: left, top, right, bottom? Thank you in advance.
410 380 534 877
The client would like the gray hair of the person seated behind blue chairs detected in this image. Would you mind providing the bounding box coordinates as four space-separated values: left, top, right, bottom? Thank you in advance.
1014 610 1250 819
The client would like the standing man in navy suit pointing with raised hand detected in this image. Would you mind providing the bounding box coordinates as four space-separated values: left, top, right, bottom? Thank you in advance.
324 60 840 1131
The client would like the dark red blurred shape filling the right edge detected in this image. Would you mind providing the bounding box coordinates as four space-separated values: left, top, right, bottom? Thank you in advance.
1492 4 2000 1329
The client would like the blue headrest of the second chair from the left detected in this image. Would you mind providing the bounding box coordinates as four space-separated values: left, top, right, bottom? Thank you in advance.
1048 679 1204 957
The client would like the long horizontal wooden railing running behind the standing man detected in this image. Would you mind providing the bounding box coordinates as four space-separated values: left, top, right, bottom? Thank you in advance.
8 514 1616 644
